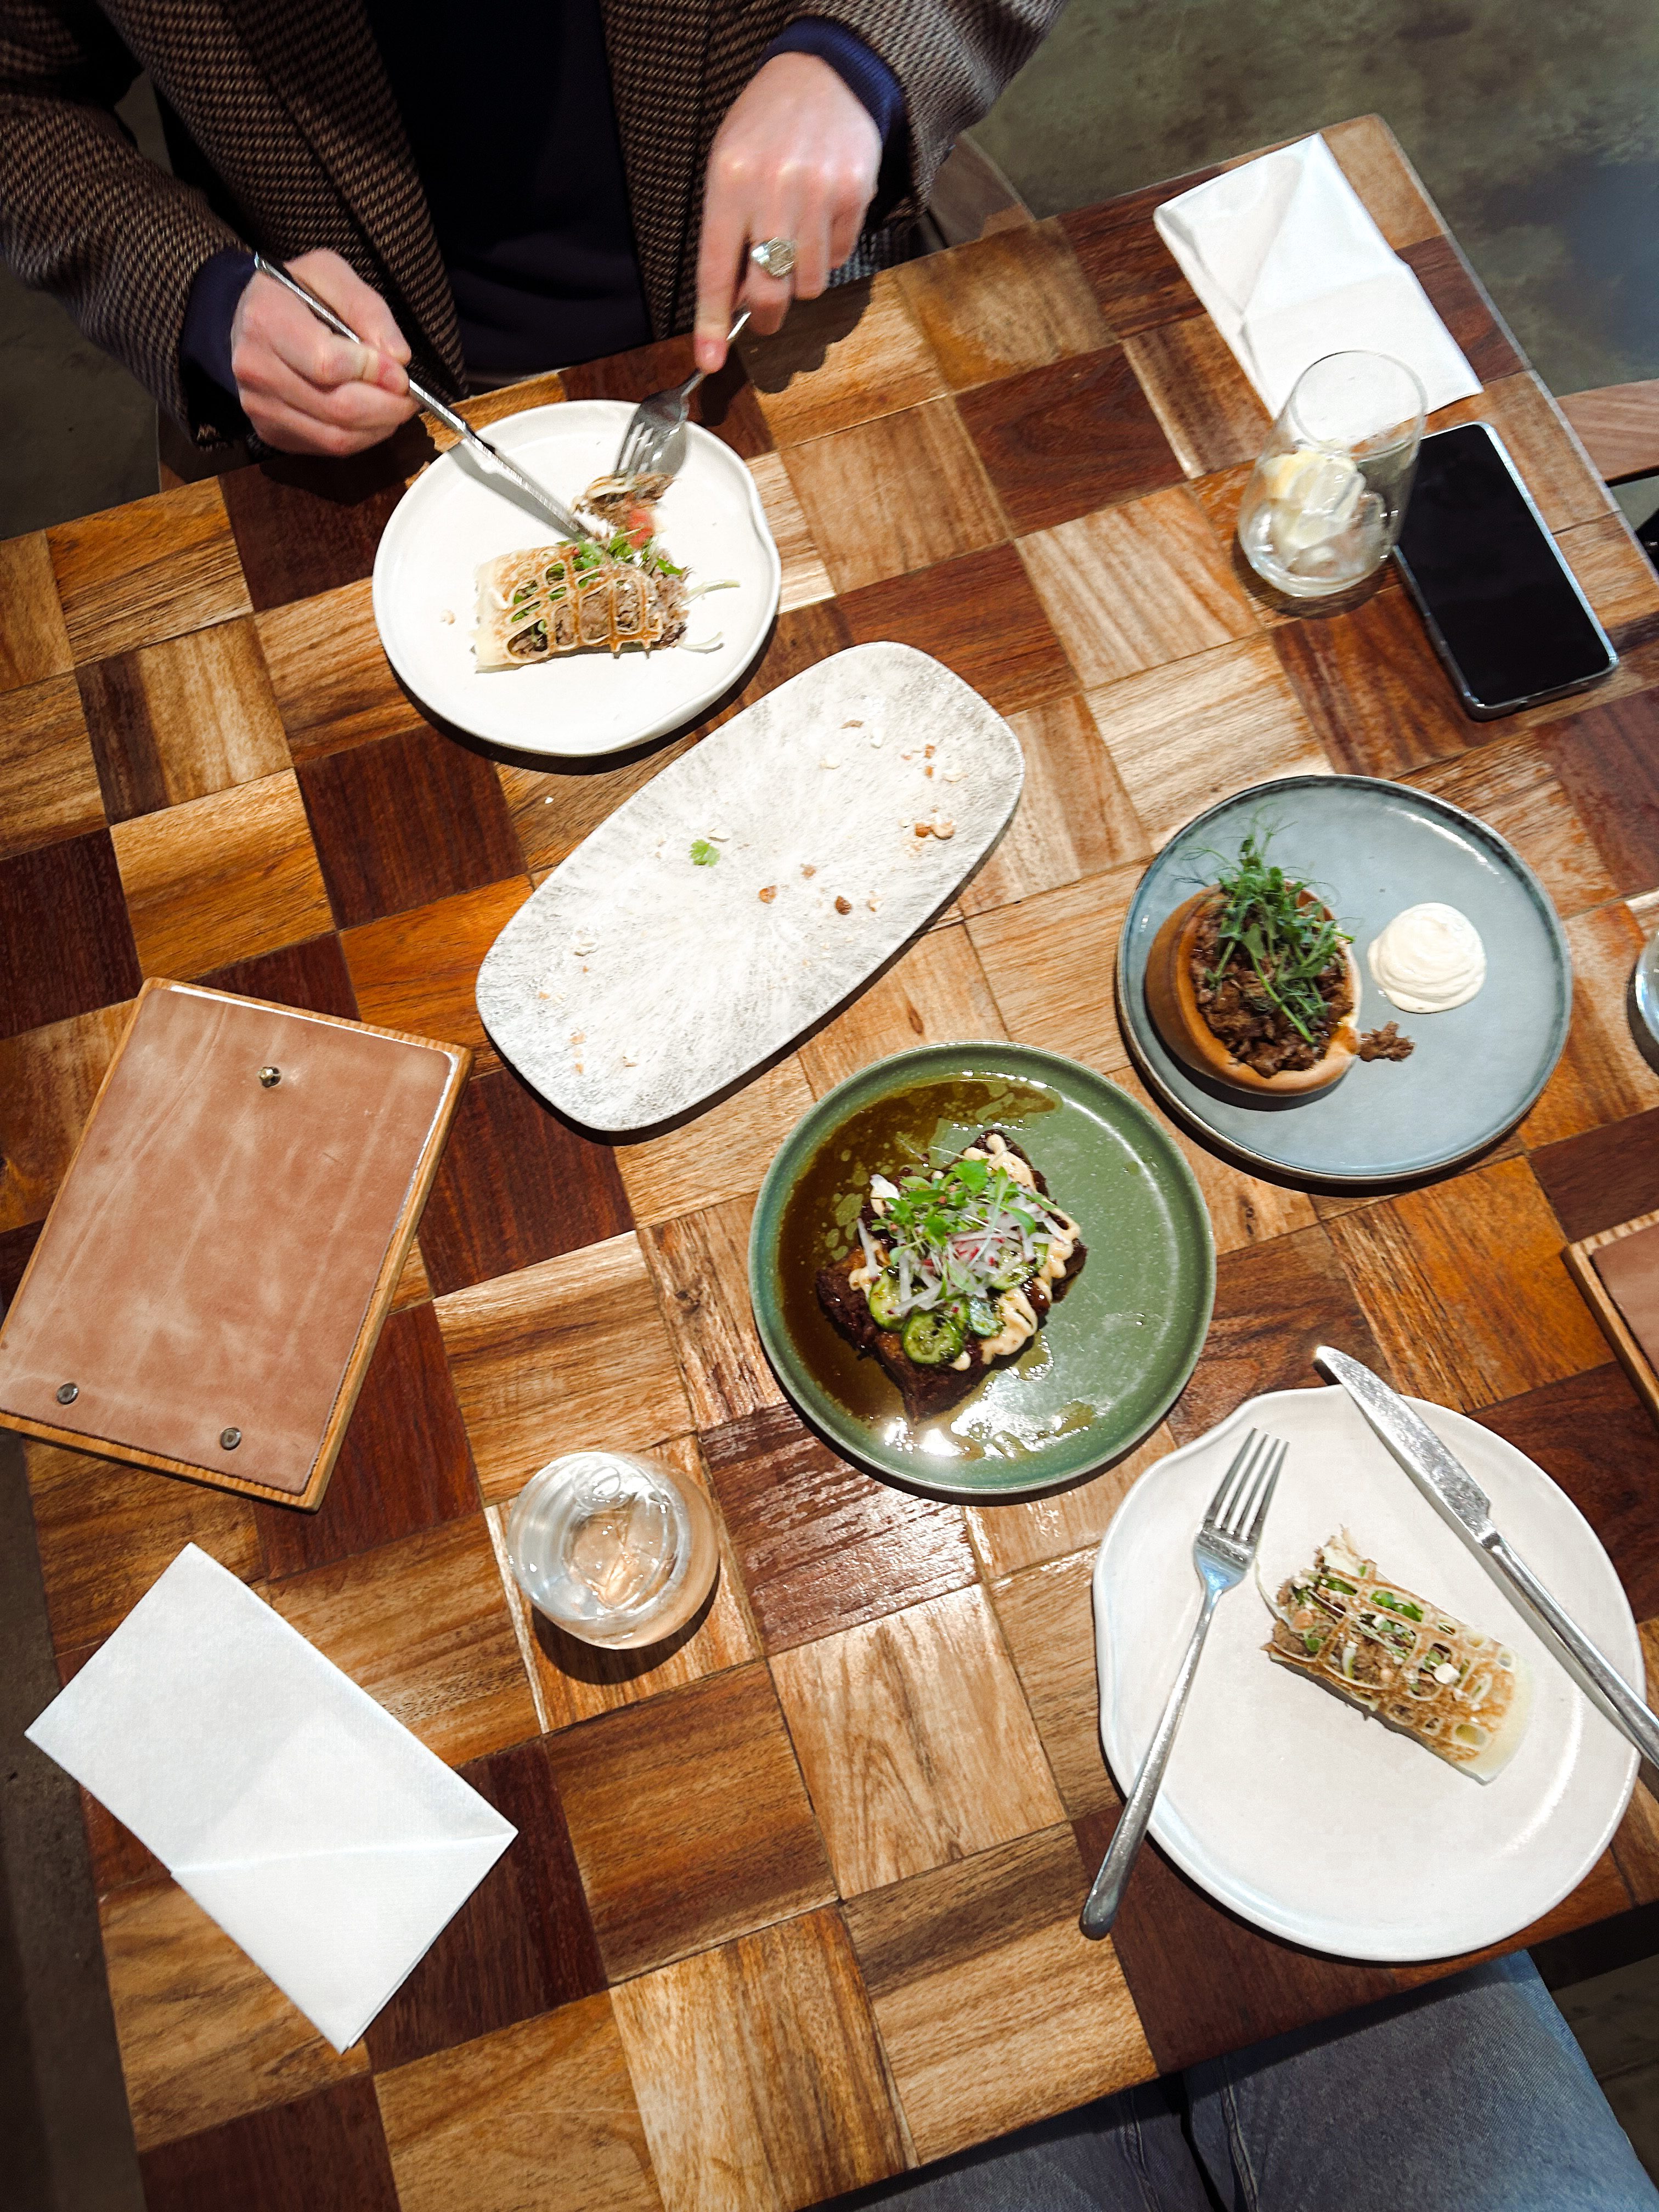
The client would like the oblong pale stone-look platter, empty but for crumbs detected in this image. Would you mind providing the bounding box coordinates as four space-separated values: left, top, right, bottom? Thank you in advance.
478 644 1024 1135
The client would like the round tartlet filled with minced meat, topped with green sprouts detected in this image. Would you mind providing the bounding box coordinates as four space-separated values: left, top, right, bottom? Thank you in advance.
1146 834 1361 1093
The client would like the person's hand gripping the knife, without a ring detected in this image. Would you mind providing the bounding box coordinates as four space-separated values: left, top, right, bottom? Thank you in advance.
230 248 416 456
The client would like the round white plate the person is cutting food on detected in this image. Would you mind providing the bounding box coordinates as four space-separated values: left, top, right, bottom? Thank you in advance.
374 400 781 759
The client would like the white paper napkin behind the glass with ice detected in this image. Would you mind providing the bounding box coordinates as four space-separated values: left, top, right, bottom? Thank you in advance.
1155 137 1480 414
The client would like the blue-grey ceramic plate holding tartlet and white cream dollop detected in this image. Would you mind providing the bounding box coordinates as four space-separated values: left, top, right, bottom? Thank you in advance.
1117 776 1573 1188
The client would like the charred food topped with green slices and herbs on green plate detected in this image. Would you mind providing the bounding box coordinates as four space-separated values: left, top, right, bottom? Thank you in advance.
816 1128 1086 1423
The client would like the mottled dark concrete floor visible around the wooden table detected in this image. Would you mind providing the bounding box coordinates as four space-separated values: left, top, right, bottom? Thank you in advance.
0 0 1659 2212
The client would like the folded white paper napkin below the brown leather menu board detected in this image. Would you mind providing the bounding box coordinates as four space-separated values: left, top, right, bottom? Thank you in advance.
26 1544 517 2051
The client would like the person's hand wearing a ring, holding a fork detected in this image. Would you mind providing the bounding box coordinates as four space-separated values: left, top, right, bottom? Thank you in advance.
697 53 881 369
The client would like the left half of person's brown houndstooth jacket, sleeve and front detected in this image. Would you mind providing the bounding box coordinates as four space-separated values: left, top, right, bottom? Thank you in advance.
0 0 462 444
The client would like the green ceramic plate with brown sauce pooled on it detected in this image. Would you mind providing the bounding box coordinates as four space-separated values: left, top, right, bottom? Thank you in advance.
750 1044 1215 1500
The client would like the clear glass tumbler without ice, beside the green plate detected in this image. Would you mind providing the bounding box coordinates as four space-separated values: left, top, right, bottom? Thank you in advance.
506 1451 719 1648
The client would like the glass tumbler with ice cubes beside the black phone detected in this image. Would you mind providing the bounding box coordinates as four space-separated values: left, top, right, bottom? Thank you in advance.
1239 352 1423 600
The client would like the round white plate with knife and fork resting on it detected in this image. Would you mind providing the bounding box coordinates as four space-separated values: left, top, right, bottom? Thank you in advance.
1095 1389 1644 1960
